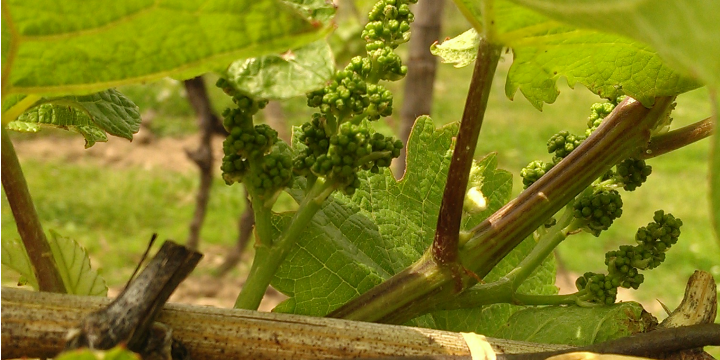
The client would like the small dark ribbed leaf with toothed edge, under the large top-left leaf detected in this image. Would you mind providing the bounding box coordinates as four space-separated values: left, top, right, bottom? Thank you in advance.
7 89 142 148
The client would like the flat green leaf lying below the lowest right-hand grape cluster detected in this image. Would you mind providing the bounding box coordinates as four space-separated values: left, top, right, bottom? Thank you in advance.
492 302 657 346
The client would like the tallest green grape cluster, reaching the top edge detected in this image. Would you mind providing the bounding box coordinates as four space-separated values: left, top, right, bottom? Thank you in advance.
293 0 417 194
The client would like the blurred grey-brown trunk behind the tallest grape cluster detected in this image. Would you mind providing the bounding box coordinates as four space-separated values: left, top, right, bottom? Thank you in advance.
395 0 445 176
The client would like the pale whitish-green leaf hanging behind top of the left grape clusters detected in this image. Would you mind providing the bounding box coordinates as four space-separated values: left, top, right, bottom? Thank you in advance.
225 40 335 99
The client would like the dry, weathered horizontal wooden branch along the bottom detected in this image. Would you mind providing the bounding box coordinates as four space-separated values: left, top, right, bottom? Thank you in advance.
0 288 567 360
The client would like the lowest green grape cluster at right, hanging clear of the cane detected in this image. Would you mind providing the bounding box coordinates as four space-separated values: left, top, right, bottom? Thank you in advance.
575 210 682 304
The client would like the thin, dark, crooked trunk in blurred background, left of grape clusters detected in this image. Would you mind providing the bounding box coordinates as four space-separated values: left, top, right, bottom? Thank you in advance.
184 76 220 250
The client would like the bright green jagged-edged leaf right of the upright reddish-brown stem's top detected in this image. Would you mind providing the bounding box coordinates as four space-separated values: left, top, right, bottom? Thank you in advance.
438 0 698 109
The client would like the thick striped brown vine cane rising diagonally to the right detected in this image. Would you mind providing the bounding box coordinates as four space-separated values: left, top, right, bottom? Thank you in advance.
328 97 673 324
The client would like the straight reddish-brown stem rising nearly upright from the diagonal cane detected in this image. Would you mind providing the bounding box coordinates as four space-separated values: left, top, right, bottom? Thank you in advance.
432 38 502 265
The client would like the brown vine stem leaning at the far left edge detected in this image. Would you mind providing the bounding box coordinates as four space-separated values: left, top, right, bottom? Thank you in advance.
0 126 66 293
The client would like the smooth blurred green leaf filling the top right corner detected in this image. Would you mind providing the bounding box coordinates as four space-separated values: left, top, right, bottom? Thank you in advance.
512 0 720 85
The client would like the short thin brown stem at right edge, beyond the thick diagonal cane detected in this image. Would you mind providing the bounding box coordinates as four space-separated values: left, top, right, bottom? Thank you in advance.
639 118 715 159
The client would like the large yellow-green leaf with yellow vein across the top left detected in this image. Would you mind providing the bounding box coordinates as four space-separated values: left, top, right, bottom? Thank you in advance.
0 0 327 95
